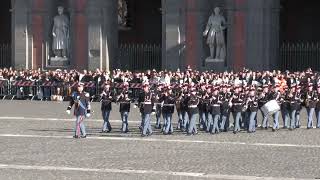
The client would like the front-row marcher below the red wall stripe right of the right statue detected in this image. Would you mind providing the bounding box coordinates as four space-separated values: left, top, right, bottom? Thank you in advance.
230 86 245 134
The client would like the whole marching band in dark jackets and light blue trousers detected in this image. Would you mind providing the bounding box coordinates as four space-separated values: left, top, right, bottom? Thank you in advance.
68 76 320 138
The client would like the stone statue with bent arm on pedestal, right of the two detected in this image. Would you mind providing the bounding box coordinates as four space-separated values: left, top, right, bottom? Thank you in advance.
203 7 226 61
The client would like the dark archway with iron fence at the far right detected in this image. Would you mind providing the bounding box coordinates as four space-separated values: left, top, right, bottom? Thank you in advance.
280 0 320 71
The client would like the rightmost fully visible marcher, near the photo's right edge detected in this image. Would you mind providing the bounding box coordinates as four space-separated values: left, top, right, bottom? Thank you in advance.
305 83 318 129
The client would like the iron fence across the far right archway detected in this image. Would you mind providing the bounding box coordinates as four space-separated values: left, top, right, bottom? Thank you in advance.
280 42 320 71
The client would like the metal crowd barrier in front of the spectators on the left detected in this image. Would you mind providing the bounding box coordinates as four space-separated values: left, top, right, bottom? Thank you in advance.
0 80 162 101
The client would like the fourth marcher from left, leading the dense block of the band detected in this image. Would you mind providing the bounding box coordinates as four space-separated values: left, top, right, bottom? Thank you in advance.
138 83 155 137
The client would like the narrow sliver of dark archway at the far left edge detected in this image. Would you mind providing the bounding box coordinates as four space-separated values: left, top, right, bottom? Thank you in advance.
0 0 11 68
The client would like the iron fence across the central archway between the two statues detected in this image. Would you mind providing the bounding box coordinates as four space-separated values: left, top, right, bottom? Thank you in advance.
119 44 161 70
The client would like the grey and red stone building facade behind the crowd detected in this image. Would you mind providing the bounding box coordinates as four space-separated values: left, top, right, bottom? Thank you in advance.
7 0 318 71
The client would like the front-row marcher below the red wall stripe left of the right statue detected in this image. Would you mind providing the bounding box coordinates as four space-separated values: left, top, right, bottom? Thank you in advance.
187 87 199 135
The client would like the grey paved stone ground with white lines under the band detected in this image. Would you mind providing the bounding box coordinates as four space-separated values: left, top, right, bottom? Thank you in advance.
0 101 320 180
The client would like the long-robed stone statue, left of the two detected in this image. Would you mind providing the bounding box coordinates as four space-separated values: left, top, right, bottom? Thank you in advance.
52 6 69 58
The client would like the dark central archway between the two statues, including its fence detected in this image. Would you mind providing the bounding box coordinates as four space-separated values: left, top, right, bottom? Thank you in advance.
119 0 162 70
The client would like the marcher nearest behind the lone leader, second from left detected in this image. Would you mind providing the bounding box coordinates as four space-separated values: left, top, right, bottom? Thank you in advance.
100 83 113 133
